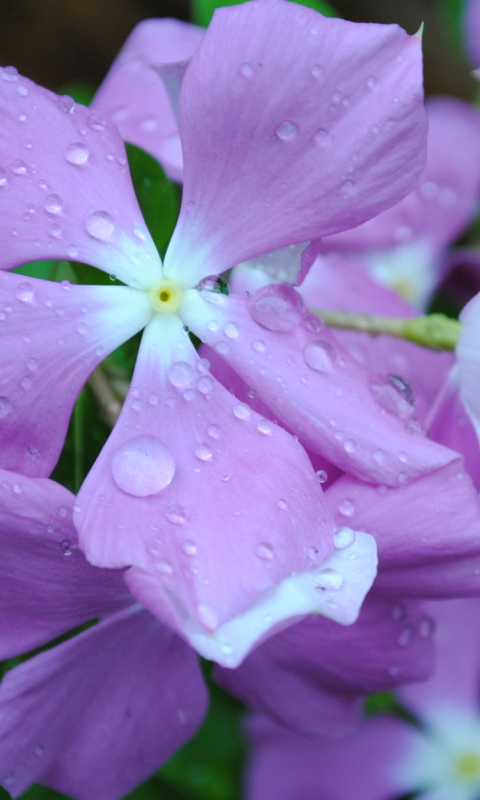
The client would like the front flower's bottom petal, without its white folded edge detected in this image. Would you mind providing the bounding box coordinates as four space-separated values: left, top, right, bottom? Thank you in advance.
76 315 344 664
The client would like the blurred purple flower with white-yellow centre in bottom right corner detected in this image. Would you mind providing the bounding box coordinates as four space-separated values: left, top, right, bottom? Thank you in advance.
246 600 480 800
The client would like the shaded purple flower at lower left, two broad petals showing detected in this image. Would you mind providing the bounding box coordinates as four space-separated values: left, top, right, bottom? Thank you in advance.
0 470 207 800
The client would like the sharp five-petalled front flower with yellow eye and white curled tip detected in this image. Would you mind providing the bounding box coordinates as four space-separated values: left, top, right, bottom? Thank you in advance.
0 0 436 666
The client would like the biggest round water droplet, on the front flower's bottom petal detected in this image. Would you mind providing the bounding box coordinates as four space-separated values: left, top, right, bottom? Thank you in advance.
111 436 175 497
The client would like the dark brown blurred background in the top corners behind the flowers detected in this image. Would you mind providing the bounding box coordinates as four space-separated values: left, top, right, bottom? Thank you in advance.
0 0 476 99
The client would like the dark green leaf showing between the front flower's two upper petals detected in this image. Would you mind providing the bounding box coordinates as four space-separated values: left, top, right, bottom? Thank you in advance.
126 142 180 257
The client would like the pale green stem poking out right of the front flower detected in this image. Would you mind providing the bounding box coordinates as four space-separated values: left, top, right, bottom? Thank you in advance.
312 309 461 350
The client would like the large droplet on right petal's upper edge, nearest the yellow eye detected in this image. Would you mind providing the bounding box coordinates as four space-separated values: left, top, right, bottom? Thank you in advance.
247 285 307 331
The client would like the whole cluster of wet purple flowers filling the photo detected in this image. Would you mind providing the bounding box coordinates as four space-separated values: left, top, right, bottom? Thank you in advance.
0 0 480 800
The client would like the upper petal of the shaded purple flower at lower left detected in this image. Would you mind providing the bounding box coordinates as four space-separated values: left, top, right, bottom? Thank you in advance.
0 470 132 660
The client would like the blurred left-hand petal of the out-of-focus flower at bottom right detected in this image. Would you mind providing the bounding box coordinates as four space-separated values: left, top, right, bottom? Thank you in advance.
246 717 424 800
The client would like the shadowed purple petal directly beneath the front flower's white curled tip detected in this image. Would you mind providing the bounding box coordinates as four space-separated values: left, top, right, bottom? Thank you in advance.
215 595 433 737
